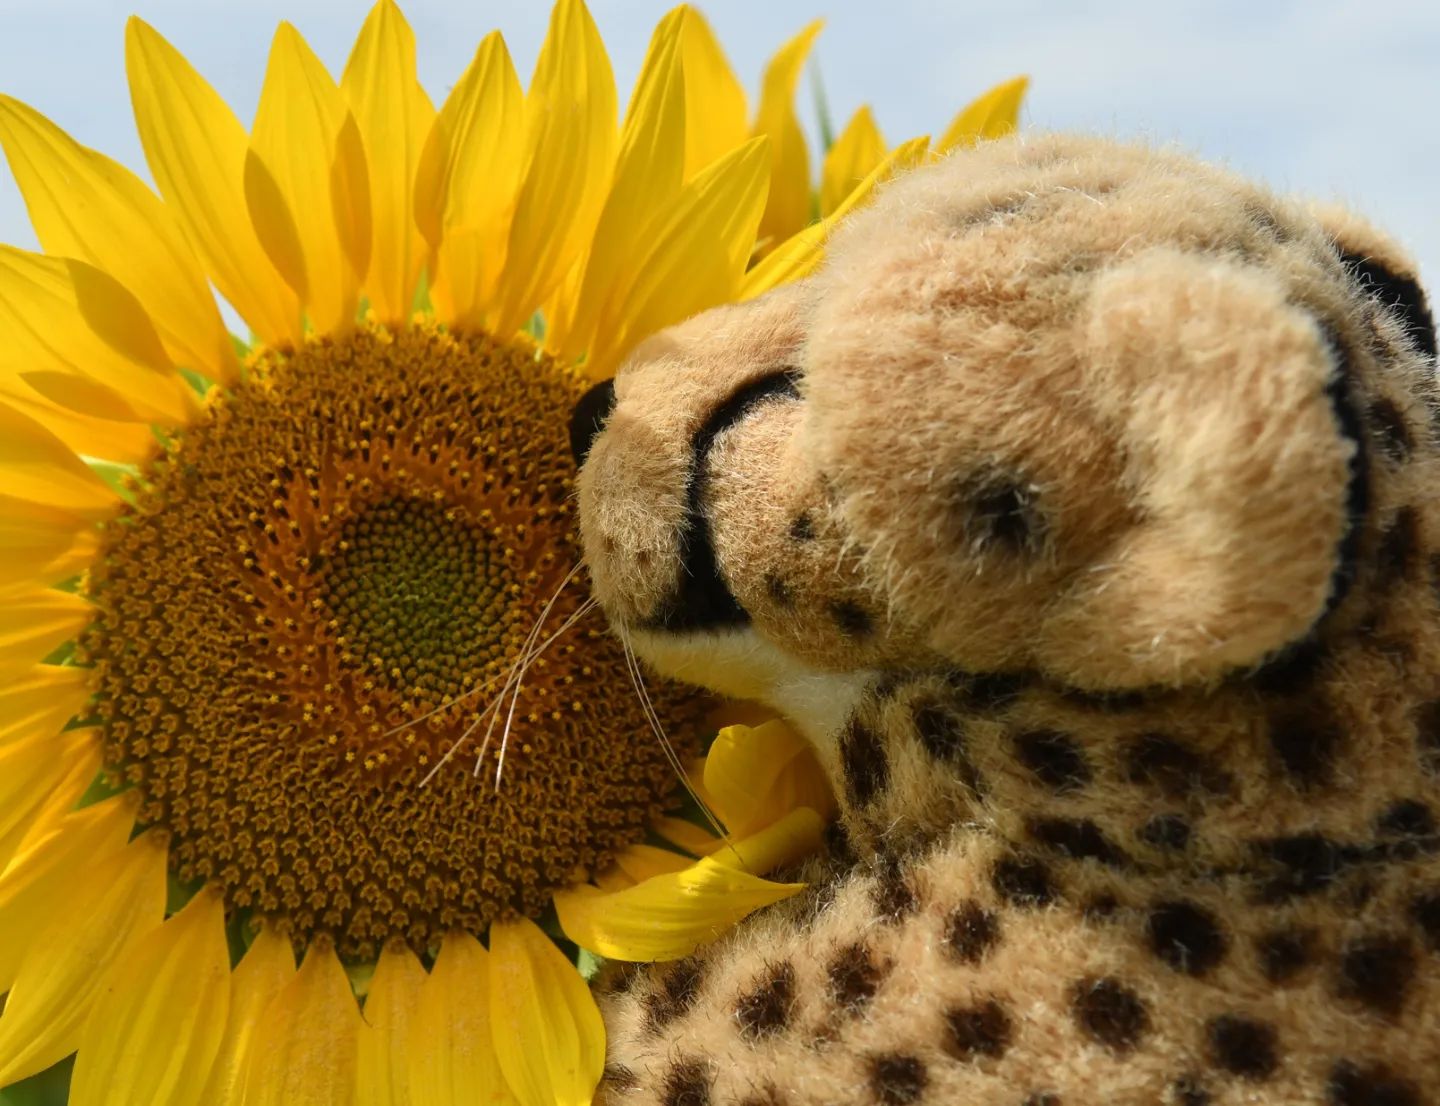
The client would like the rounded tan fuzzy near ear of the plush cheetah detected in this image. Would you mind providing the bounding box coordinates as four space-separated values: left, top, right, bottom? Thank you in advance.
1035 249 1358 690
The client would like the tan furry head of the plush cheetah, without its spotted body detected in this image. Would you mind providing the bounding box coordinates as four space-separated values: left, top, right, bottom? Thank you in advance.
576 137 1434 734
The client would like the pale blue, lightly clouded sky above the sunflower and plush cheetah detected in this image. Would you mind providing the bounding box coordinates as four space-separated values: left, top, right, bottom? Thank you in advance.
0 0 1440 289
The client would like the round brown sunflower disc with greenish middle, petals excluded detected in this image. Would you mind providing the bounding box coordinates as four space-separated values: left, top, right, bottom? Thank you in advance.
82 327 696 958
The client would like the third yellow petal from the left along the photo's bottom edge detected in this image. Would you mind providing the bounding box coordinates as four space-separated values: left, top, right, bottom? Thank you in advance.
245 942 363 1106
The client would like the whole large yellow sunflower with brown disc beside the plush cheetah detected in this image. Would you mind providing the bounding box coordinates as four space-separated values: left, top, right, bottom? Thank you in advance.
0 0 1014 1106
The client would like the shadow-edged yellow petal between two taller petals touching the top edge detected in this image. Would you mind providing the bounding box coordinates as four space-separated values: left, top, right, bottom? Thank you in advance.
415 32 526 324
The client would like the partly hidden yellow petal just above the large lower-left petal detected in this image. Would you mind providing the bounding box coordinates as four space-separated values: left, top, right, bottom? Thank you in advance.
0 796 135 991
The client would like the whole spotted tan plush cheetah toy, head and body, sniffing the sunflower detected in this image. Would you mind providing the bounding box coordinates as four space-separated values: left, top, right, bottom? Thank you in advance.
580 137 1440 1106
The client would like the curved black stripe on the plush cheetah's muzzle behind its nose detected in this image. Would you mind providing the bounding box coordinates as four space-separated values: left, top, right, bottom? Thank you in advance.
639 369 801 634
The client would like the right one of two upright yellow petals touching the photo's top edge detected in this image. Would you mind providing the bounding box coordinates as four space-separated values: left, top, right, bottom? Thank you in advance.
495 0 615 336
